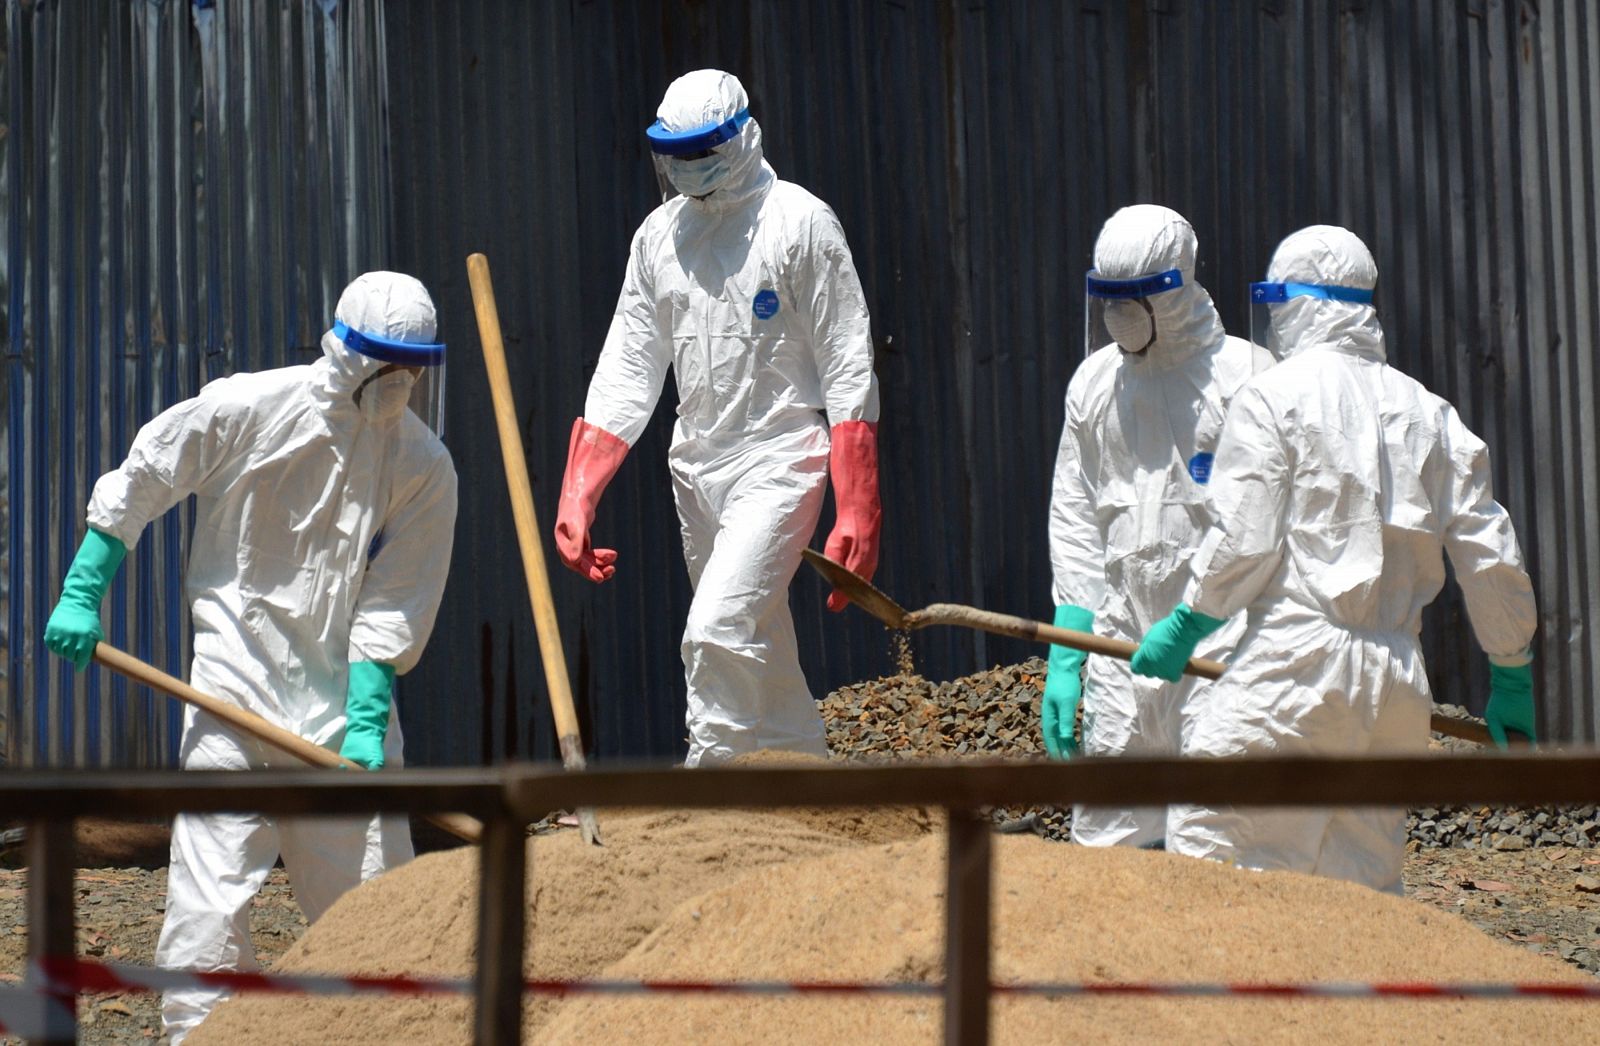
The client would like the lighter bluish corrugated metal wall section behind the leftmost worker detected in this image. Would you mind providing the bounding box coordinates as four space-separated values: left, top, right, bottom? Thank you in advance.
0 0 389 766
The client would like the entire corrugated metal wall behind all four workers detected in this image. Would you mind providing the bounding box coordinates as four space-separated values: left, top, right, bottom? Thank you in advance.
0 0 1600 763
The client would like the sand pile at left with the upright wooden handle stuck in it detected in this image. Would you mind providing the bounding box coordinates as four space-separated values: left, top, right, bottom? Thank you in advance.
187 767 938 1046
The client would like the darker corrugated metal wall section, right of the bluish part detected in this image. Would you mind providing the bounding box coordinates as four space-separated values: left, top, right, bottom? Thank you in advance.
386 0 1600 761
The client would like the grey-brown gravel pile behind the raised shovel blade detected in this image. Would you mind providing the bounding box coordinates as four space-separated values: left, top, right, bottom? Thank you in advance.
821 657 1600 851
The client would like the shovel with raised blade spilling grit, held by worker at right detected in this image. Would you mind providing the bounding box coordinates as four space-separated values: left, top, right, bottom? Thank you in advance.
800 549 1491 745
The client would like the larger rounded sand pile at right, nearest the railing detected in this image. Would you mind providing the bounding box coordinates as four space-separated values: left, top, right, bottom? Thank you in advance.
539 836 1600 1043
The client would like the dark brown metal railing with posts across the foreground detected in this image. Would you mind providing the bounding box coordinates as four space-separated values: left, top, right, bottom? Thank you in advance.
0 752 1600 1044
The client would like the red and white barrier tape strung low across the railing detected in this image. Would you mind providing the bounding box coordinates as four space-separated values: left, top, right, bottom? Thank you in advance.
21 960 1600 1000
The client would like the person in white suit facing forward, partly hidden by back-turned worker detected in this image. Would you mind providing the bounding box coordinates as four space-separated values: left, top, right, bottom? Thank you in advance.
1042 205 1272 846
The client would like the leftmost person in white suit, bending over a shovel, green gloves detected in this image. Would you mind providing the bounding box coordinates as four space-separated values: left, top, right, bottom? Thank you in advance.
45 272 456 1043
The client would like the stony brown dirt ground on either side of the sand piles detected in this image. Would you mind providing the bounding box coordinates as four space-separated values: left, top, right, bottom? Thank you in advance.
0 824 1600 1046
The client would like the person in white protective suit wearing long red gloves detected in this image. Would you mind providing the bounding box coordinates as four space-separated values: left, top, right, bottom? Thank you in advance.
555 69 882 766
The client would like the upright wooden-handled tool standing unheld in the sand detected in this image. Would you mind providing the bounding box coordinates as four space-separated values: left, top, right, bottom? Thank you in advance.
467 254 600 843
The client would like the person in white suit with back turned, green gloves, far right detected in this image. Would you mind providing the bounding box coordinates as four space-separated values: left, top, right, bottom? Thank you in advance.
1133 226 1538 892
